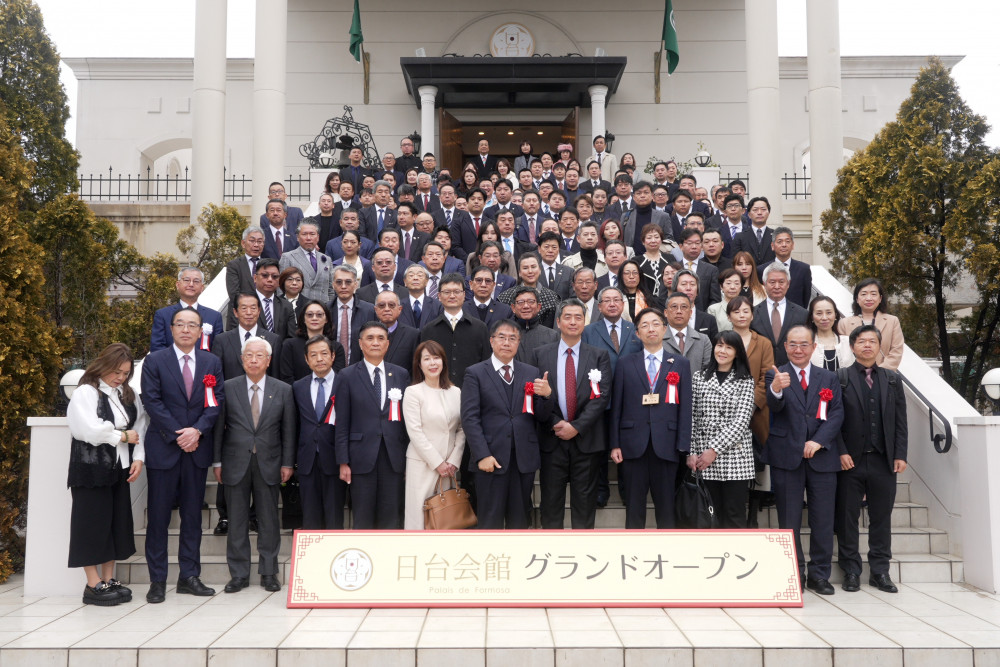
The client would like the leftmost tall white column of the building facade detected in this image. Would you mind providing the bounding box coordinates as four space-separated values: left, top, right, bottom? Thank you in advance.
191 0 226 224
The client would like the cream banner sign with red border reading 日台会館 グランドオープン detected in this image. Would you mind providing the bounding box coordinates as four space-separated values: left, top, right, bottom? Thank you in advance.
288 530 802 608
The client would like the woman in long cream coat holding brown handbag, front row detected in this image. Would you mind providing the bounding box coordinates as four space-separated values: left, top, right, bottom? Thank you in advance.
403 340 465 530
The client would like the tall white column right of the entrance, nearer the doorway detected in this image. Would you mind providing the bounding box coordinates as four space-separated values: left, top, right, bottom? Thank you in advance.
746 0 782 226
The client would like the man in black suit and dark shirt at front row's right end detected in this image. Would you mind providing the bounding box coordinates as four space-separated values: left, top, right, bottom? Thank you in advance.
834 325 907 593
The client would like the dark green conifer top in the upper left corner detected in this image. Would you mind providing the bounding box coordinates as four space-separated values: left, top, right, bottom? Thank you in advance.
0 0 79 211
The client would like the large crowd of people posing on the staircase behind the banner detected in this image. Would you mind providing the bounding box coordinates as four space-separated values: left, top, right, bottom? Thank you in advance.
69 136 906 605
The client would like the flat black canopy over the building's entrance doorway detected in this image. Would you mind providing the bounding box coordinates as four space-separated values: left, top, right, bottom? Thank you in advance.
399 56 627 109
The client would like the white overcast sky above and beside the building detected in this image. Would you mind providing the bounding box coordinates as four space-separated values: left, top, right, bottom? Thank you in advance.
35 0 1000 146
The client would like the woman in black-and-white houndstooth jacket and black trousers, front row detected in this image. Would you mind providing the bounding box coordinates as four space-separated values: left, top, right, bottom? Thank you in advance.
687 331 754 528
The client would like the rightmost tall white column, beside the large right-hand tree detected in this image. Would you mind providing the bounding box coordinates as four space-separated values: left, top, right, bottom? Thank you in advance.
806 0 844 265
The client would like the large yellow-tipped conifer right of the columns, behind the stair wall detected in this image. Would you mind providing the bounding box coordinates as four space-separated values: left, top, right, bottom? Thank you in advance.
820 58 996 398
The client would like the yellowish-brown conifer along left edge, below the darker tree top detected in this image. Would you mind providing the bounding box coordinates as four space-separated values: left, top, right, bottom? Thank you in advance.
0 114 69 582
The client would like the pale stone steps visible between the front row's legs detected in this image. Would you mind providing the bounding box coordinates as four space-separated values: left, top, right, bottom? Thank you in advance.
118 465 963 588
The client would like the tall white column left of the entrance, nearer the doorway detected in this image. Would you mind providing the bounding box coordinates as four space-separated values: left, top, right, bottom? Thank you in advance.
251 0 288 220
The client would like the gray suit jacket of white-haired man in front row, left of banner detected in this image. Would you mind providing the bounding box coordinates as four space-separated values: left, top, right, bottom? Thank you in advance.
214 376 298 486
